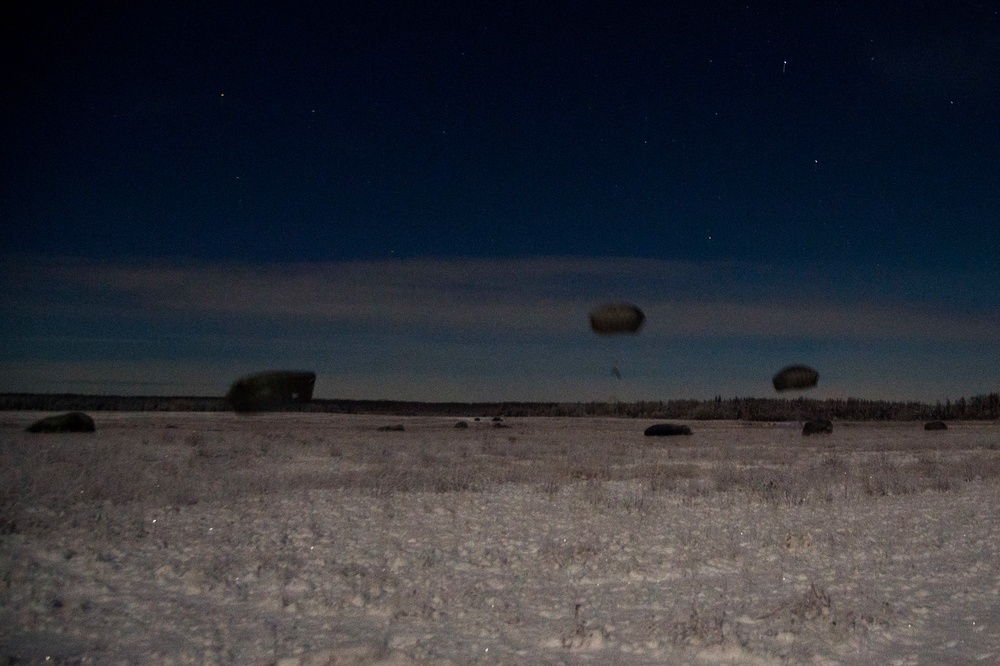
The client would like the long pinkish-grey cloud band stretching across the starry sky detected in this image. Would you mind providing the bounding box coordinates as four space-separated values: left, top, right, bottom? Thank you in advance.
5 252 997 341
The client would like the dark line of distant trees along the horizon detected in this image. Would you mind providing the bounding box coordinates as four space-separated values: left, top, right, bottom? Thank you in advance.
0 393 1000 421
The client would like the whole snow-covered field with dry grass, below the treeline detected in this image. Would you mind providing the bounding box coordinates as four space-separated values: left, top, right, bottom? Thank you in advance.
0 412 1000 665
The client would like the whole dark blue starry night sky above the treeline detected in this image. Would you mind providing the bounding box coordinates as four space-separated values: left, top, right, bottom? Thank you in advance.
0 0 1000 401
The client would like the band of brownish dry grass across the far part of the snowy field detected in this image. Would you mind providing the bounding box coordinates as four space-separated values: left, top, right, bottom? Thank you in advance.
0 417 1000 536
